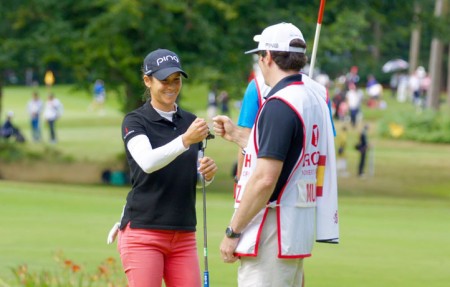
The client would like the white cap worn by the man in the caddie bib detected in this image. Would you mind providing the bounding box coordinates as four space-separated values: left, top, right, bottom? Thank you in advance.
245 22 306 54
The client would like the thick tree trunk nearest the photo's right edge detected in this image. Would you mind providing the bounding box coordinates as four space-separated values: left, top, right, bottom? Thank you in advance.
427 0 444 111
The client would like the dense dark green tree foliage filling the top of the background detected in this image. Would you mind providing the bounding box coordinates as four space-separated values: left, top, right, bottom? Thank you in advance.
0 0 446 116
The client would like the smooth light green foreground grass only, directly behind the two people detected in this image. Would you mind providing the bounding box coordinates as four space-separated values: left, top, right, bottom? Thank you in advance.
0 181 450 287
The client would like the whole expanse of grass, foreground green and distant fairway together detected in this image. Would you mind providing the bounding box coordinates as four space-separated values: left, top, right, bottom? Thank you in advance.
0 85 450 287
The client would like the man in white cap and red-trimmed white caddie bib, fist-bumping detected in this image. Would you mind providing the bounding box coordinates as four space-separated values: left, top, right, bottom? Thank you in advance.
214 23 339 287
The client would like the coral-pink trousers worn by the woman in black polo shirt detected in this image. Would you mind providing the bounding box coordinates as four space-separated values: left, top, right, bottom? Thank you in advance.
117 225 202 287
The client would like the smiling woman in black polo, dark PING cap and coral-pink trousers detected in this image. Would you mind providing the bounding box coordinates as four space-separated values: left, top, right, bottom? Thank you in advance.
118 49 217 287
